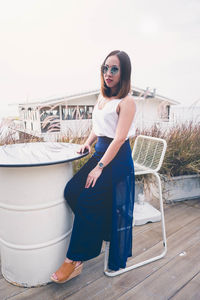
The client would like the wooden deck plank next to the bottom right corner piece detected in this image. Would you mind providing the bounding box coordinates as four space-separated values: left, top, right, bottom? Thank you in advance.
118 241 200 300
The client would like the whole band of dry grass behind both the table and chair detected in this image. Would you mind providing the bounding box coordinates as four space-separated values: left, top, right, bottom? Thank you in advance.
0 117 200 177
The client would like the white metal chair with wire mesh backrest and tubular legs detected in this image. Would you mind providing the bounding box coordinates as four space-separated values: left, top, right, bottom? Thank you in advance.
104 135 167 276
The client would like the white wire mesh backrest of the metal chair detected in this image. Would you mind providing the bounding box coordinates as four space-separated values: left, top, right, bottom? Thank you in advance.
132 135 167 172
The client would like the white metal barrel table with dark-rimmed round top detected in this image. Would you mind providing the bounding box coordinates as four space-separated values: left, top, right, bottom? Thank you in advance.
0 143 87 287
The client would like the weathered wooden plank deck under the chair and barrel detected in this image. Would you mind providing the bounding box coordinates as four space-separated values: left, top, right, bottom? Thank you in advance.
0 199 200 300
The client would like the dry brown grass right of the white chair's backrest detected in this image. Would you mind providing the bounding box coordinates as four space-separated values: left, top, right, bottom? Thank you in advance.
134 123 200 177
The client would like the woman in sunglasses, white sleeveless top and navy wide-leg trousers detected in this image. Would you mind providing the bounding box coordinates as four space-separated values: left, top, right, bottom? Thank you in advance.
51 50 136 283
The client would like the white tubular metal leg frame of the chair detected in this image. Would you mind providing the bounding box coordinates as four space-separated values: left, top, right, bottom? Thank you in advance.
104 173 167 277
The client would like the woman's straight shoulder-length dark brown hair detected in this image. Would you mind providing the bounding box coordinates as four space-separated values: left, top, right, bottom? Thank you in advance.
101 50 131 99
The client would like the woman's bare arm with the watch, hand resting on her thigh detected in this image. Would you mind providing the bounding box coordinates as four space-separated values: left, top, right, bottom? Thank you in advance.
85 96 136 188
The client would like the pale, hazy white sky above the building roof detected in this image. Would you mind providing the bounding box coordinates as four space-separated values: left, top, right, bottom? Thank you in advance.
0 0 200 117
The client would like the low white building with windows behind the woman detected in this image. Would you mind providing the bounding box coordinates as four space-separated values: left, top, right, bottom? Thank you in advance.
19 87 179 137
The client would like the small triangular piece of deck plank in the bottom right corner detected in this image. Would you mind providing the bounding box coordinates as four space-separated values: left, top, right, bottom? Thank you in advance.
170 272 200 300
